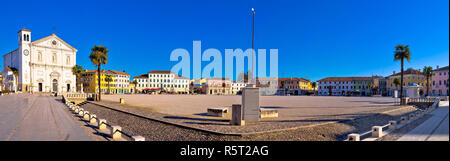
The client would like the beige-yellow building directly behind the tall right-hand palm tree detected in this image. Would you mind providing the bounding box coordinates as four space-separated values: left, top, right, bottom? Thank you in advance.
386 68 427 96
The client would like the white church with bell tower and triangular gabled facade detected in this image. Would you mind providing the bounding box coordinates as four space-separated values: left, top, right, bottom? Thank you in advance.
1 29 77 92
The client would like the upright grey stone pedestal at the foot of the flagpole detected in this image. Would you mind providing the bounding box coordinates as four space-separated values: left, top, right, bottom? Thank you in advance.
242 87 260 123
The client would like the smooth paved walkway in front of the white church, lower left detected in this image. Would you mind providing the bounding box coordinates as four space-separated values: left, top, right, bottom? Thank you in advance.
0 94 92 141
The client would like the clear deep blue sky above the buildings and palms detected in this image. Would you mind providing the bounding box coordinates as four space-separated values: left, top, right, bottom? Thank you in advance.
0 0 449 80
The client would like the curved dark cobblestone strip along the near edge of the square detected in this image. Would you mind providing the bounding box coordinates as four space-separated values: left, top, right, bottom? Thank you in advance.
81 100 416 141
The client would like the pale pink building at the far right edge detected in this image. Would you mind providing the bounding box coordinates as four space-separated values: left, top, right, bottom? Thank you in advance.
431 66 449 96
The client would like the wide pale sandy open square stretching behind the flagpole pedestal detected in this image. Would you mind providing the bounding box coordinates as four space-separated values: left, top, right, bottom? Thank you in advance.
102 94 395 120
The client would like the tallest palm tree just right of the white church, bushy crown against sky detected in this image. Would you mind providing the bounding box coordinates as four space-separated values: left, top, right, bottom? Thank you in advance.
89 45 109 101
